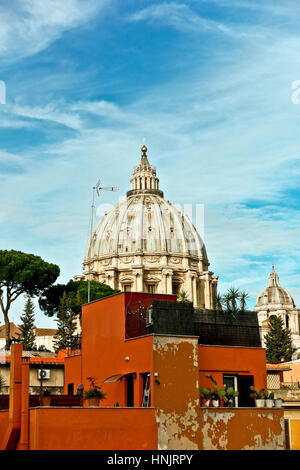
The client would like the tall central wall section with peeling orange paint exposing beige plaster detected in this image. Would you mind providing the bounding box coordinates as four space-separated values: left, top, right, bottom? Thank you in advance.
153 336 200 450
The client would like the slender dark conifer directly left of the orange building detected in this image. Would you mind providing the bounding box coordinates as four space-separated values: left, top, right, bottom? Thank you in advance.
54 292 78 352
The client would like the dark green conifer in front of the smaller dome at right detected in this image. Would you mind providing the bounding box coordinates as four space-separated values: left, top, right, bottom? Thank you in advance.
265 315 294 364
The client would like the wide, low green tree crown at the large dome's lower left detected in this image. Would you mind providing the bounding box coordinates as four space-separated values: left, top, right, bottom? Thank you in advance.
39 279 119 317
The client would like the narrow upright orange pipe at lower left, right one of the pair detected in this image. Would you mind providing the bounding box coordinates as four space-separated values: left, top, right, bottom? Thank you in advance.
19 357 30 450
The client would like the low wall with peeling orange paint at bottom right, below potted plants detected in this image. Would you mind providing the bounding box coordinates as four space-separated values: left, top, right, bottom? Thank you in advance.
199 408 285 450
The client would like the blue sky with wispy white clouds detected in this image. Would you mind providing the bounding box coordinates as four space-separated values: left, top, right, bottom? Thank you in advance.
0 0 300 327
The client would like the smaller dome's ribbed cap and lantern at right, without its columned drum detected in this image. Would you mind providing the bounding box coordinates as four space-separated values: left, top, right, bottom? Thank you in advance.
255 266 295 310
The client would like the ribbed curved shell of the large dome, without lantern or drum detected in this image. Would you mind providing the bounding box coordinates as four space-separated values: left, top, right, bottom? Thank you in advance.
87 193 207 262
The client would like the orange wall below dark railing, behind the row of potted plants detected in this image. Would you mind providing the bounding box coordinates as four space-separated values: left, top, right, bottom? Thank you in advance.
198 345 267 389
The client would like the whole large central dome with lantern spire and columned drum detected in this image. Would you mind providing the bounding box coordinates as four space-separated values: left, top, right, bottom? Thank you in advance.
82 146 218 309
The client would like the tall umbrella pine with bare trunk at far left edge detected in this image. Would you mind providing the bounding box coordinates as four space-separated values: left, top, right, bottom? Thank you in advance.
0 250 59 349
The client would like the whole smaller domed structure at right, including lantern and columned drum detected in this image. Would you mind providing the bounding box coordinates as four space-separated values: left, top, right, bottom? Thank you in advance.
255 266 300 359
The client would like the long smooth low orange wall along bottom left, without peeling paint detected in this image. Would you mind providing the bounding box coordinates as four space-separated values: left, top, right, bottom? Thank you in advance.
29 408 157 450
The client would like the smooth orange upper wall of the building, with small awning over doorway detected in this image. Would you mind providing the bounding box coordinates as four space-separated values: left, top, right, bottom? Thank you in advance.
82 293 176 406
